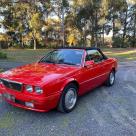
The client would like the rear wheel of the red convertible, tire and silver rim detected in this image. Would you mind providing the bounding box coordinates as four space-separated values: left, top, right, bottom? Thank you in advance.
105 71 116 87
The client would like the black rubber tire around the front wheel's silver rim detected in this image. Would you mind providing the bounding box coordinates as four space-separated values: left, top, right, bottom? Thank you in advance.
57 83 78 113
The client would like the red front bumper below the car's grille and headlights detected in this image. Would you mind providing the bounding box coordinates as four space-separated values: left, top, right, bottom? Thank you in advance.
0 85 60 112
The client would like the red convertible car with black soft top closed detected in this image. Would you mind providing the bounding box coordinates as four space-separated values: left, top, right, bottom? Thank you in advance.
0 48 117 113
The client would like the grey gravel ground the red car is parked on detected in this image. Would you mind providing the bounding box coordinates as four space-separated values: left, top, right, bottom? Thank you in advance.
0 62 136 136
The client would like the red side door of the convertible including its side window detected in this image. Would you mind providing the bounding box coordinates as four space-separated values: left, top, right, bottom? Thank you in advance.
80 49 106 94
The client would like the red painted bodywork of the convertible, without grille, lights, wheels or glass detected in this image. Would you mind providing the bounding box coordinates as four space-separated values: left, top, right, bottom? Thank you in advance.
0 48 117 112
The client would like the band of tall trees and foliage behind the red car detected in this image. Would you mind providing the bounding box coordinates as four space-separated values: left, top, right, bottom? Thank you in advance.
0 0 136 49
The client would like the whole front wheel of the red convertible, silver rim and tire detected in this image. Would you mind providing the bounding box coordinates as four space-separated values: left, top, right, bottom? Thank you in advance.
58 83 78 113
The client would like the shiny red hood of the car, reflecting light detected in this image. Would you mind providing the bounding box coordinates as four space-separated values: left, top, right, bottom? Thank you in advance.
0 63 78 85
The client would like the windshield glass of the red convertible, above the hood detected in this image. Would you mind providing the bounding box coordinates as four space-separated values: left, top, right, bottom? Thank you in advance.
40 49 84 65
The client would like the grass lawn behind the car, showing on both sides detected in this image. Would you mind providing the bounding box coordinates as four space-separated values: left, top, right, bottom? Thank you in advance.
2 48 136 63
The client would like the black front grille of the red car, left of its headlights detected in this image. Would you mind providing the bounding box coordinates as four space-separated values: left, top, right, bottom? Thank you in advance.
0 79 22 91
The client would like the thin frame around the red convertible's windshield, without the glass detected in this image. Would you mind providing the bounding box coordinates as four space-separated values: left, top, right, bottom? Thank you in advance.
38 48 85 67
